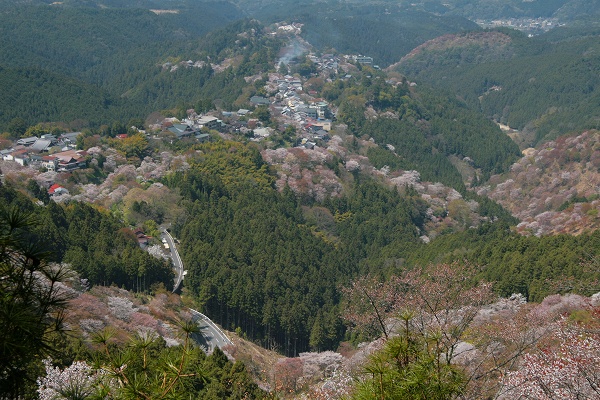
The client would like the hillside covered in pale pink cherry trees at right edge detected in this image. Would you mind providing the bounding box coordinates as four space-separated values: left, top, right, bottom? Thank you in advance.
478 130 600 236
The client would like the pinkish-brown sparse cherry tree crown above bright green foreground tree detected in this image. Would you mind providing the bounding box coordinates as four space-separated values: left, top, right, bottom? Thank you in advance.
343 262 496 346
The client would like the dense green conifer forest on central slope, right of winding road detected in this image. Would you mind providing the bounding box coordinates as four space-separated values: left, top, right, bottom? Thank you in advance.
166 142 432 354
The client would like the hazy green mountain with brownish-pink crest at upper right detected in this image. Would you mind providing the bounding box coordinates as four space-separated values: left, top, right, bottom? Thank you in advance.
395 28 600 147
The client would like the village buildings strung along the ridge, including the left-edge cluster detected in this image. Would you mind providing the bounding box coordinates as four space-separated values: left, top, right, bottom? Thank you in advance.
0 48 372 193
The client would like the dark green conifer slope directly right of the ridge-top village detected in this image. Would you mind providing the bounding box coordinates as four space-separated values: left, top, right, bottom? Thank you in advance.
332 76 519 191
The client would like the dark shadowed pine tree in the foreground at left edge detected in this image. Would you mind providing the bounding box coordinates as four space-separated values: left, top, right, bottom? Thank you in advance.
0 204 69 398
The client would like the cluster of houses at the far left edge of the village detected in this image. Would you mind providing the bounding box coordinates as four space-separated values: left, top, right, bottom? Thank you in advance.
0 132 87 172
